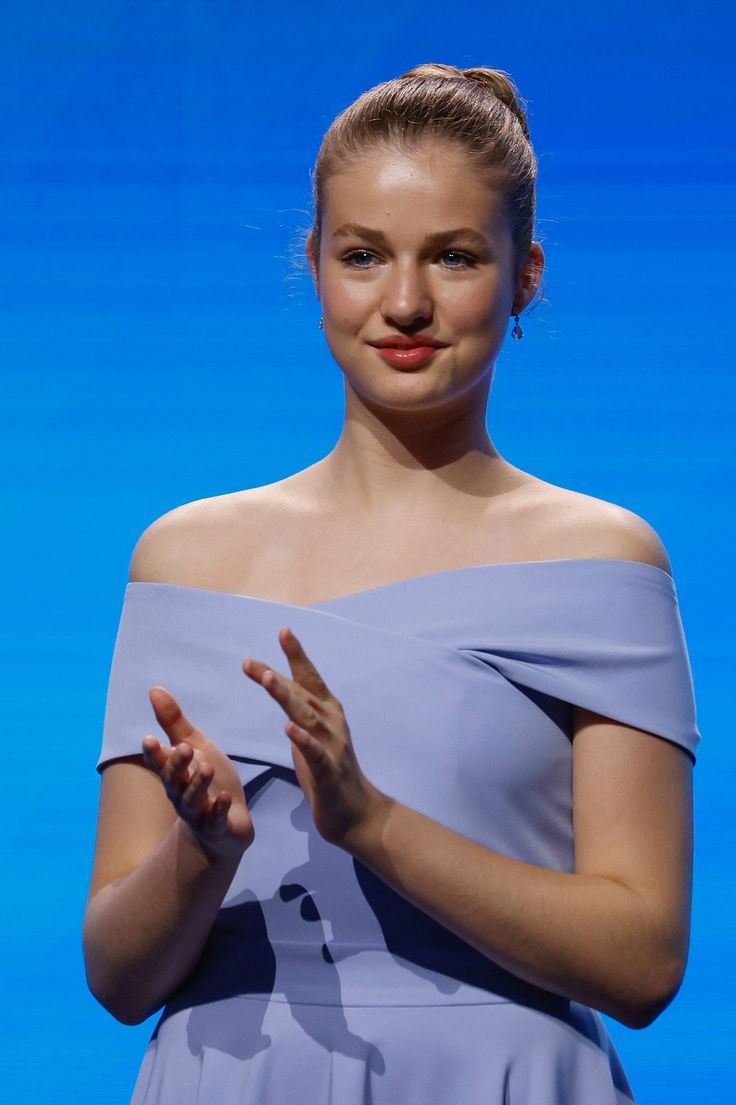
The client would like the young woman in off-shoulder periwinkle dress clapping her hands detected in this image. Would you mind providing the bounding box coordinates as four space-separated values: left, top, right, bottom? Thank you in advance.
83 64 700 1105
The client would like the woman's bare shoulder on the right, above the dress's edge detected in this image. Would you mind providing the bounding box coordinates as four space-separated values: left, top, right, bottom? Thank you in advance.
528 484 672 575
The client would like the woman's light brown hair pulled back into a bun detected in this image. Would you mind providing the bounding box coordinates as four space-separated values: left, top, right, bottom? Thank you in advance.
302 62 537 298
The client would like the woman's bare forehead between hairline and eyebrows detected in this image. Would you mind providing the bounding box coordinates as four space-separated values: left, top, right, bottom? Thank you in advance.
323 141 505 233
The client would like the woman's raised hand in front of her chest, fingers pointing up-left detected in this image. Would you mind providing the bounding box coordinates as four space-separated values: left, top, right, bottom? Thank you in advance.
243 627 390 851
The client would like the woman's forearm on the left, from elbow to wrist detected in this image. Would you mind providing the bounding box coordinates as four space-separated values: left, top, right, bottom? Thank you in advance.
83 818 240 1024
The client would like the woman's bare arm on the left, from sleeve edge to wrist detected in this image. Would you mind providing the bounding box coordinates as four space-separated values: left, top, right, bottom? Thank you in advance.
82 762 245 1024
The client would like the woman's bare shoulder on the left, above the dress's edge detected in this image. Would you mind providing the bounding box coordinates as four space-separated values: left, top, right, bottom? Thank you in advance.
129 485 277 587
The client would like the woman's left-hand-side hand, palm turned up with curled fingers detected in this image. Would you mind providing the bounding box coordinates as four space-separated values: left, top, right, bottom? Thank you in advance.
143 686 255 857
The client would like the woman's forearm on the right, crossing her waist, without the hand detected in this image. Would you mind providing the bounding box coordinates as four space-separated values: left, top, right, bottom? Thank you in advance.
344 798 671 1028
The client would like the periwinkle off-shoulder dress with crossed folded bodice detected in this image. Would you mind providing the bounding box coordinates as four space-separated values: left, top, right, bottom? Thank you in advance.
97 558 701 1105
